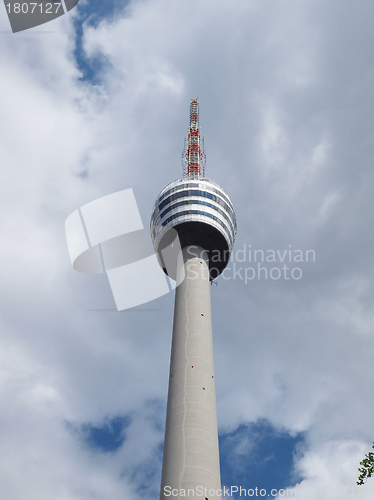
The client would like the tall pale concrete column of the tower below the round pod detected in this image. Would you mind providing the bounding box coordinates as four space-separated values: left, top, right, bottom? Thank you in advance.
160 245 221 500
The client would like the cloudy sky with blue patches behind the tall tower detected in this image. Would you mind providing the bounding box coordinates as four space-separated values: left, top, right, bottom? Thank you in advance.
0 0 374 500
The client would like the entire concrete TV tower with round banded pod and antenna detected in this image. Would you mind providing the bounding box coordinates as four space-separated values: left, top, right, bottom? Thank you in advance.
151 99 236 500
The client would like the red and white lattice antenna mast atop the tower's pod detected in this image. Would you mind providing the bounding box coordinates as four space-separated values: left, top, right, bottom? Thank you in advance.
182 99 206 178
